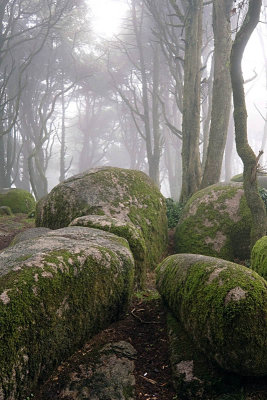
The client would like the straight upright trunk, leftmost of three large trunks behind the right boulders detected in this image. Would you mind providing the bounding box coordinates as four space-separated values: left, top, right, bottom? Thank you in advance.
180 0 203 202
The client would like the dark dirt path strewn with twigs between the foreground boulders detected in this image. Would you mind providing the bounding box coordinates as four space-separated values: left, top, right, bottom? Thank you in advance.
34 290 178 400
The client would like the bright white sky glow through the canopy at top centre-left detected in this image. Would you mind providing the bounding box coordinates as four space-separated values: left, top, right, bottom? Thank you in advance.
87 0 127 38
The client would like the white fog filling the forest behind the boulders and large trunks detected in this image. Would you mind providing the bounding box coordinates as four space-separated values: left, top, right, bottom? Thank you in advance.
0 0 267 200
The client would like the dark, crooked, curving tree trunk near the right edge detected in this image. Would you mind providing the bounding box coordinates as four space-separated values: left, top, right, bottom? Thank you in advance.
230 0 267 247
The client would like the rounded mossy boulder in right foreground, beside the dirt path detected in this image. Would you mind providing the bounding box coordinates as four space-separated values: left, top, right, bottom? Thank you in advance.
157 254 267 376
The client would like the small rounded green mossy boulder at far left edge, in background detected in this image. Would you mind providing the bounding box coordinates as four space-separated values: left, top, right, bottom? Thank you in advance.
0 189 35 214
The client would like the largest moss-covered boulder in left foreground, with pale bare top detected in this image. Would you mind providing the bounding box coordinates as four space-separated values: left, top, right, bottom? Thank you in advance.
0 227 134 400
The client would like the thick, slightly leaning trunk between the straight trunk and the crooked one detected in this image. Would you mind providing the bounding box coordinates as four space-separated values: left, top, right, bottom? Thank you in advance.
201 0 233 188
